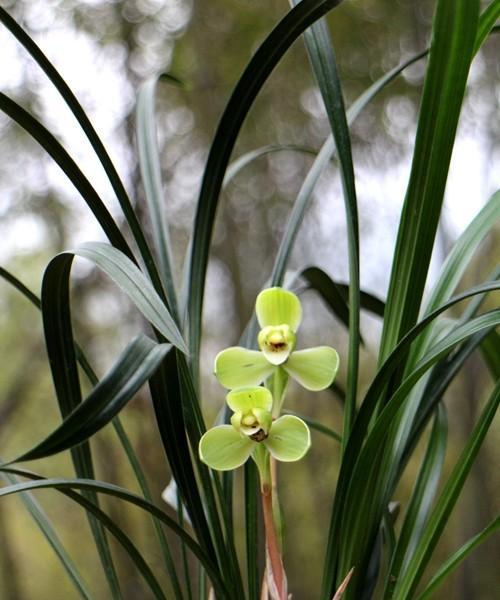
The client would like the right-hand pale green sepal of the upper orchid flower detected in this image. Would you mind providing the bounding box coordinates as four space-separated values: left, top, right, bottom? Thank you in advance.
282 346 339 392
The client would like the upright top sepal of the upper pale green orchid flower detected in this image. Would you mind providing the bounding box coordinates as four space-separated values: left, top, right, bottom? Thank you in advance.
255 287 302 331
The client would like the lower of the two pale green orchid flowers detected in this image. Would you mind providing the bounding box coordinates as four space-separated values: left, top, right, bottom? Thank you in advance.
198 387 311 471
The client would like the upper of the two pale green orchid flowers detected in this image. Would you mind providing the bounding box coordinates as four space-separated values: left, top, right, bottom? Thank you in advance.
215 287 339 391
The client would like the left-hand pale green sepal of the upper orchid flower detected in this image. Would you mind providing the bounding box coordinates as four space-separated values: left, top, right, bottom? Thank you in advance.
214 346 274 390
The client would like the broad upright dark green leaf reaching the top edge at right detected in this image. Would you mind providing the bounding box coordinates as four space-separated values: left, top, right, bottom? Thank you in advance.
380 0 479 362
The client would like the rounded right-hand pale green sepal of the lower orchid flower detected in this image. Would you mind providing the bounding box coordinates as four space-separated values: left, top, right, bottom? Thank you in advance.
264 415 311 462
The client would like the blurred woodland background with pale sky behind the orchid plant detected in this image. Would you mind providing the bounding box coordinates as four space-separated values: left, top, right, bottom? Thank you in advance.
0 0 500 600
